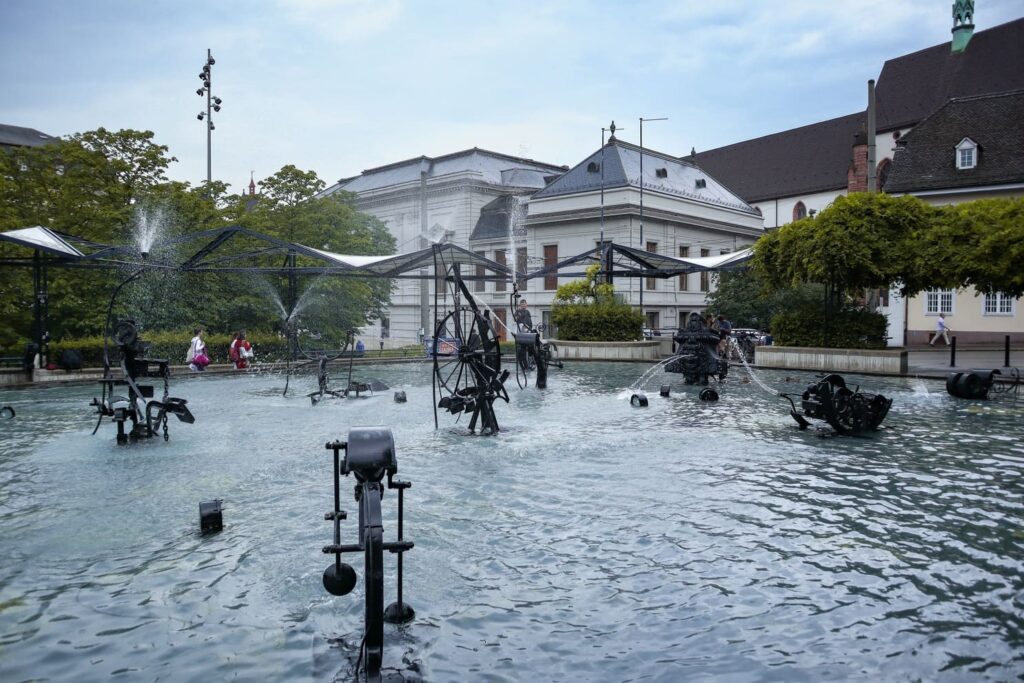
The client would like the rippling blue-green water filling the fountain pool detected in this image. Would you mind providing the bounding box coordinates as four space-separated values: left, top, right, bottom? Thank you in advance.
0 364 1024 681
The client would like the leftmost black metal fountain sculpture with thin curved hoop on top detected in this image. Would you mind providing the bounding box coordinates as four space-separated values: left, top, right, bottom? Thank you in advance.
90 321 196 443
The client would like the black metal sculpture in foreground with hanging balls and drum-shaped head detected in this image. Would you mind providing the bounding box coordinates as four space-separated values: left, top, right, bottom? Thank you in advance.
324 427 416 681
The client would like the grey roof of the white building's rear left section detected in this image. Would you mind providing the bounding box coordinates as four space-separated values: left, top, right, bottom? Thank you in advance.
319 147 565 197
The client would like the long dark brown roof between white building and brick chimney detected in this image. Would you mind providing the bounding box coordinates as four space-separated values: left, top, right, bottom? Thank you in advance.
683 113 865 202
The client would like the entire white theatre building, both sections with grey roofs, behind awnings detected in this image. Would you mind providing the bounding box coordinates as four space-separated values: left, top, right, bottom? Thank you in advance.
325 137 763 347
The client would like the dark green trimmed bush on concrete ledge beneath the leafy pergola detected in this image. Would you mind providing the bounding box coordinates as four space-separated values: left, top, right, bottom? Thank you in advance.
771 306 886 348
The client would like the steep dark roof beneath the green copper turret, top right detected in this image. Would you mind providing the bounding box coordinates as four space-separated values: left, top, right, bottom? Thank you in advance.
874 18 1024 131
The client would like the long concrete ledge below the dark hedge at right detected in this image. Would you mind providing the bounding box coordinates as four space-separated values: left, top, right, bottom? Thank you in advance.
757 346 907 375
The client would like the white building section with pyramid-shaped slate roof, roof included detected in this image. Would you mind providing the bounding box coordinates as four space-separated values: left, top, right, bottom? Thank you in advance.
470 137 763 337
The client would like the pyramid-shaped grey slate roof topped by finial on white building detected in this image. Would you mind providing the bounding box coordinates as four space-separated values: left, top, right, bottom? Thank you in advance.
530 137 757 214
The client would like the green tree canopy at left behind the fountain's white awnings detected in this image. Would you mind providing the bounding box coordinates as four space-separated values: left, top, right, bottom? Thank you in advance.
0 128 395 348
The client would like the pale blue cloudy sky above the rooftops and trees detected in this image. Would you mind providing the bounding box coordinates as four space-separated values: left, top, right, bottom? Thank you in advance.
0 0 1024 191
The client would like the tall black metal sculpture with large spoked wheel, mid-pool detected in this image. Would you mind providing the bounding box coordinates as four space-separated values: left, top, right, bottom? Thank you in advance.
431 265 509 434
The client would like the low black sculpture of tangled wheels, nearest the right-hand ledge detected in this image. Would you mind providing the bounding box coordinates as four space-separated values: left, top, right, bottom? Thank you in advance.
779 375 893 435
